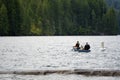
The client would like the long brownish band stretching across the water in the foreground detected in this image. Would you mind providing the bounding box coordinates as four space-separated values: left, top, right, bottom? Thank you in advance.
0 69 120 77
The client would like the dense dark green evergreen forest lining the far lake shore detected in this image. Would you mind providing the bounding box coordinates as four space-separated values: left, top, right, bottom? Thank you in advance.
0 0 120 36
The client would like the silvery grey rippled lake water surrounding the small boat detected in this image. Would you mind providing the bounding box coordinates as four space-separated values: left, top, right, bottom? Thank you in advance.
0 36 120 80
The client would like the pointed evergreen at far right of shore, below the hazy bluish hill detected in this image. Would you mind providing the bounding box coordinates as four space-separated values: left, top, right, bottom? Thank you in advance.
103 8 118 34
